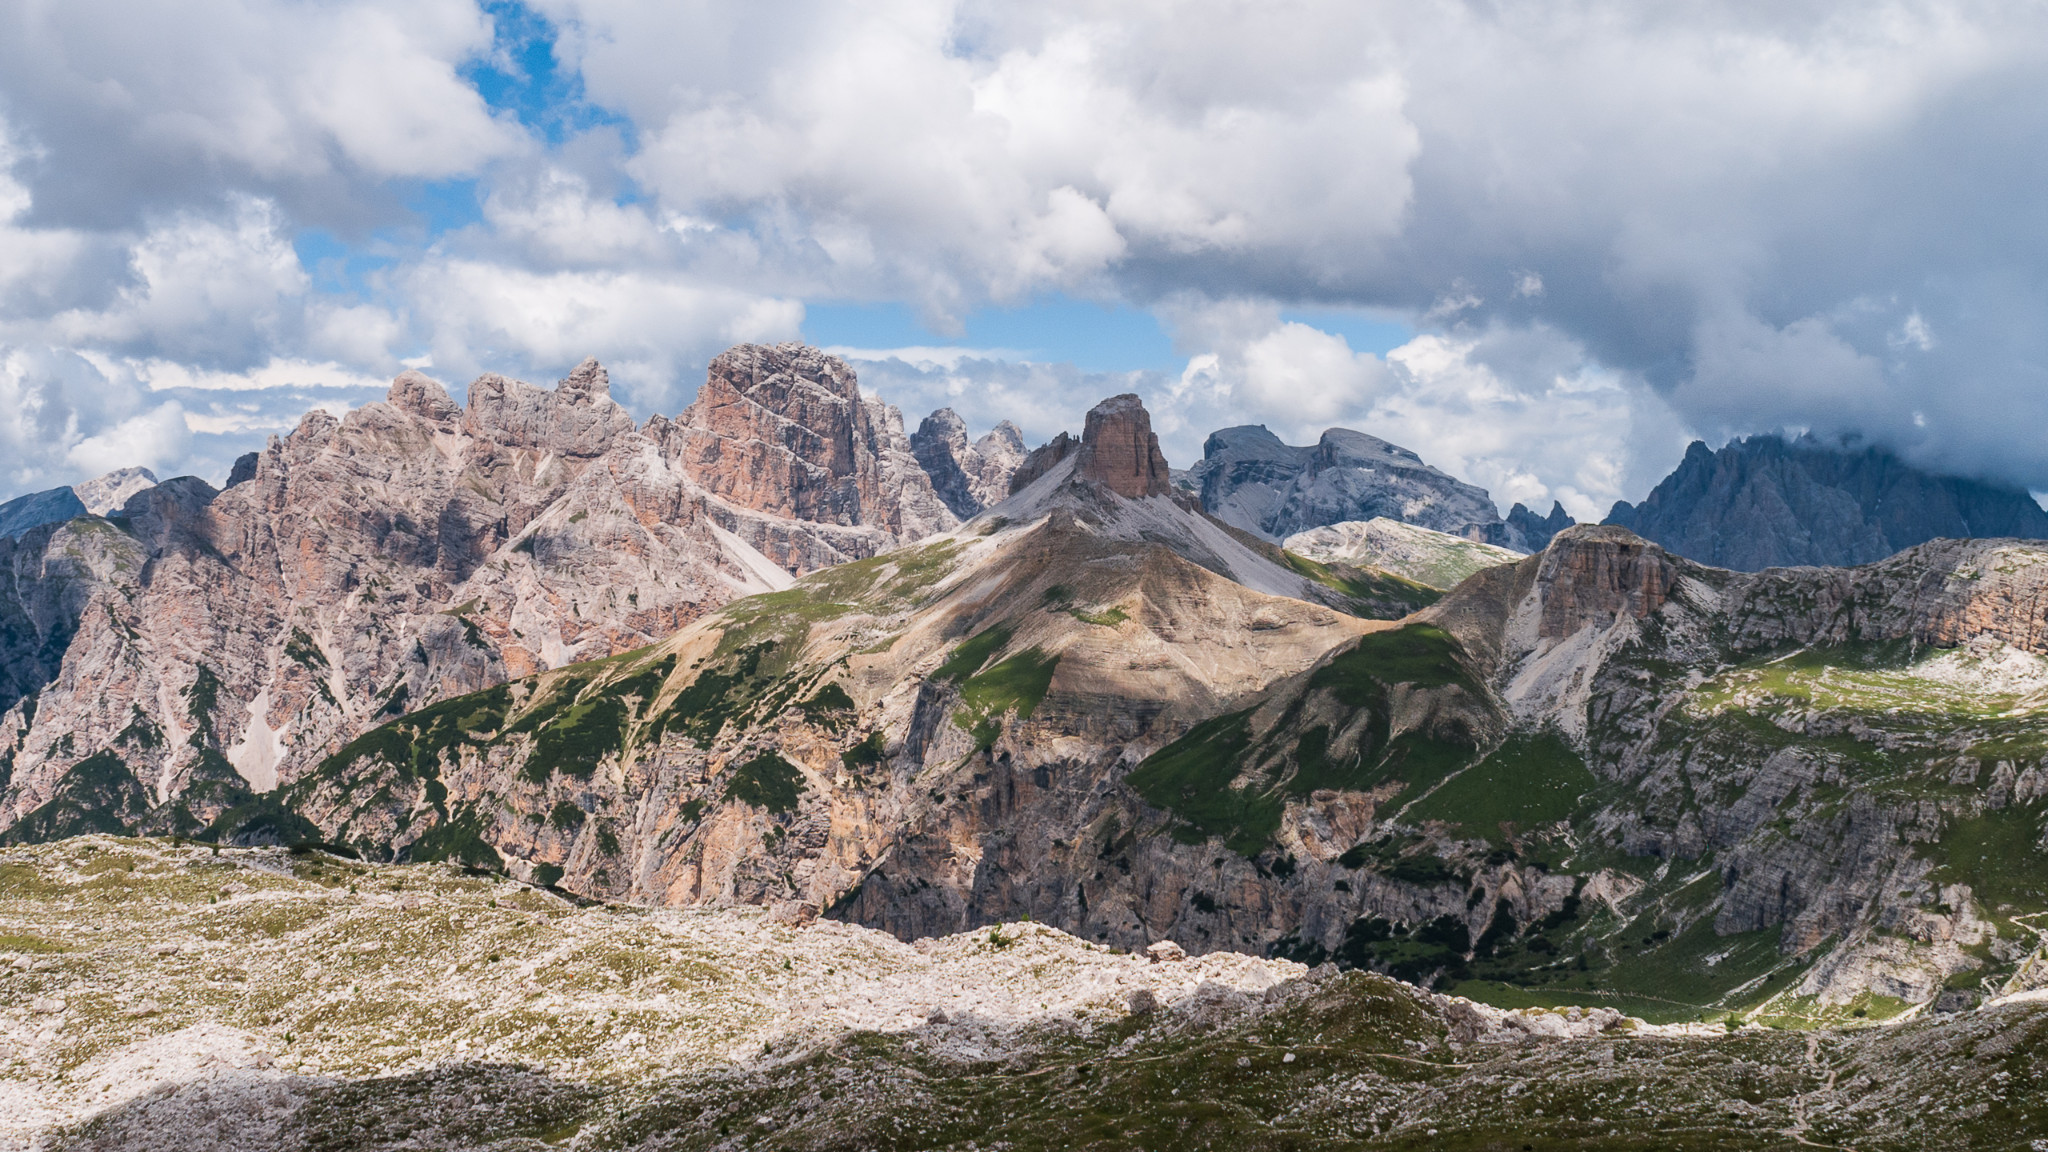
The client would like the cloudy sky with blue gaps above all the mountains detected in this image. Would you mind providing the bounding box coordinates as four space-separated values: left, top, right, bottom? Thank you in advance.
0 0 2048 519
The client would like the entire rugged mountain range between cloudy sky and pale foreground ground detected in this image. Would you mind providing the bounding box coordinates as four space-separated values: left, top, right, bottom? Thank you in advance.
0 344 2048 1021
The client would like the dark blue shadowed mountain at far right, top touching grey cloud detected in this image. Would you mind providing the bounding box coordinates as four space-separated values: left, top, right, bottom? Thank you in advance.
1606 437 2048 572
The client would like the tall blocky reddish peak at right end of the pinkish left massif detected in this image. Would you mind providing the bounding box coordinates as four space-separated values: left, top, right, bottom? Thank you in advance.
672 344 958 572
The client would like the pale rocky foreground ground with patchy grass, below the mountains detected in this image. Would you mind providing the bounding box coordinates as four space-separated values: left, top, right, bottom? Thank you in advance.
0 836 2048 1152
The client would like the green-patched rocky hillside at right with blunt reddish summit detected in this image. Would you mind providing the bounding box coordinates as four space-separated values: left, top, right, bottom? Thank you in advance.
1128 529 2048 1019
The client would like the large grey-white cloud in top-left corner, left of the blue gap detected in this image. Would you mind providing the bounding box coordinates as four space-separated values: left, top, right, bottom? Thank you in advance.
0 0 522 182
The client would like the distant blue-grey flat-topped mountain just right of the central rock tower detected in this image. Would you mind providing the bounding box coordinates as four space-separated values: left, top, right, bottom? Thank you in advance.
1188 424 1516 545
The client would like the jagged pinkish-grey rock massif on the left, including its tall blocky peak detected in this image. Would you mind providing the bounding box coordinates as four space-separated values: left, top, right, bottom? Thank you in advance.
0 346 954 838
